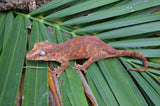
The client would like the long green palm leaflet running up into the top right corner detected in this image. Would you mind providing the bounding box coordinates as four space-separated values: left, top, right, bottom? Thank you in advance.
59 0 160 25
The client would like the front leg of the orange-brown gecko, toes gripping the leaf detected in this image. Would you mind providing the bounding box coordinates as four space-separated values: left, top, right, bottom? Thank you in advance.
52 61 69 78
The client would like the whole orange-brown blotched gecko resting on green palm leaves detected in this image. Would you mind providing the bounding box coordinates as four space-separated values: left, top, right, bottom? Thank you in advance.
26 36 148 76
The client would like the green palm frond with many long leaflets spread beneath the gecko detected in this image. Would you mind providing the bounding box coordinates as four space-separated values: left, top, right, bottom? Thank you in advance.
0 0 160 106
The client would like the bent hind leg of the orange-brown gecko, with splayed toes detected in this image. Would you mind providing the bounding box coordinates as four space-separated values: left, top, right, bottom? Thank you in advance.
72 51 108 73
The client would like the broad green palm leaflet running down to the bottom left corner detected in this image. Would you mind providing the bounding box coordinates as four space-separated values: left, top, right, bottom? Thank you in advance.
0 16 27 105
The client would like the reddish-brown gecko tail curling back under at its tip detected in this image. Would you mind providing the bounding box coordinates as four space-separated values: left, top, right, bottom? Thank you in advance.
117 50 148 71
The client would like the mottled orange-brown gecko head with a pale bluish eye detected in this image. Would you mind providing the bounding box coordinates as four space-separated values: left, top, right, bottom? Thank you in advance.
26 40 59 61
